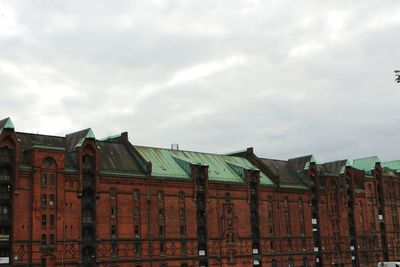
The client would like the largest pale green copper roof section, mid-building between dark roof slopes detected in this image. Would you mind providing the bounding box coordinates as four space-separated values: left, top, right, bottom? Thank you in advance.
135 146 272 185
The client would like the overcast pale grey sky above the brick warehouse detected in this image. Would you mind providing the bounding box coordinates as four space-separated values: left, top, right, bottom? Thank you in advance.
0 0 400 162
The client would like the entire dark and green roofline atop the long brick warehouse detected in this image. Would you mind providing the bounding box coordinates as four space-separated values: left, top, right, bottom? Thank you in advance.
0 118 400 184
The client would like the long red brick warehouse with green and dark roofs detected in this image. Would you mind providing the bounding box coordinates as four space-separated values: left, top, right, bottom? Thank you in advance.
0 118 400 267
